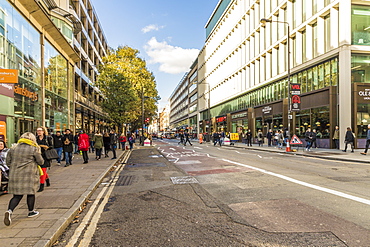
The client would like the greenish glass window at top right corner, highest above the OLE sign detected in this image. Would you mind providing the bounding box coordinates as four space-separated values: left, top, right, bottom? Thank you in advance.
352 5 370 45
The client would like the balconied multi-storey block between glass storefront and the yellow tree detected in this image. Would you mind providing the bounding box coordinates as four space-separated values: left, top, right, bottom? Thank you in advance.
70 0 110 132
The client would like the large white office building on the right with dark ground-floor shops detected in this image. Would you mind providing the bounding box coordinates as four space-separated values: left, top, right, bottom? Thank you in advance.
192 0 370 147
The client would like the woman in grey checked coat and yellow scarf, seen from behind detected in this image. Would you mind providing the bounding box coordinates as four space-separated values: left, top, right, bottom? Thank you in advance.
4 132 44 226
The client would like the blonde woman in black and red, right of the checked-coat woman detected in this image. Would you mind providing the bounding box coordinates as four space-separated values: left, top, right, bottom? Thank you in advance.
36 127 53 192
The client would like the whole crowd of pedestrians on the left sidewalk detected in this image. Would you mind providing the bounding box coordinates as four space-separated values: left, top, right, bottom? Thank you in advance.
0 127 135 226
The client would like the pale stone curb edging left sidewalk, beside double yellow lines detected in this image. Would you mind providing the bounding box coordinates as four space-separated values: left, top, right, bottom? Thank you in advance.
34 150 126 247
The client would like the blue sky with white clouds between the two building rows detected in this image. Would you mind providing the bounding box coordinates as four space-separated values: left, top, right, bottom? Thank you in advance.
91 0 218 108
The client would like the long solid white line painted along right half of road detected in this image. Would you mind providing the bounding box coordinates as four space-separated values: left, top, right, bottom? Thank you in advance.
222 159 370 205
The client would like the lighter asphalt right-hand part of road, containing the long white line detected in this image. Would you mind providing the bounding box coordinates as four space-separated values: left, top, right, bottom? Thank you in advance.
159 140 370 246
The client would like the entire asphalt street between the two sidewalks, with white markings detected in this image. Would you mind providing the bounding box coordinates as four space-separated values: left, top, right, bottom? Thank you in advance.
52 140 370 246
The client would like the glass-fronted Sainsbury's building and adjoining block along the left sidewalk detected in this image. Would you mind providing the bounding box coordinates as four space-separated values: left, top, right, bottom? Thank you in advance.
0 0 107 144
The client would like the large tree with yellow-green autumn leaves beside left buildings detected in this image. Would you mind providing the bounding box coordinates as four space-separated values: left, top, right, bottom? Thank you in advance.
96 46 160 129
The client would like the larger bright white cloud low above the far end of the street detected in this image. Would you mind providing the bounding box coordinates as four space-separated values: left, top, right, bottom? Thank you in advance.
144 37 199 74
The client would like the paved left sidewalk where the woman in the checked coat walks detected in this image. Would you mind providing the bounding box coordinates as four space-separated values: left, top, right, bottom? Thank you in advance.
0 150 123 247
